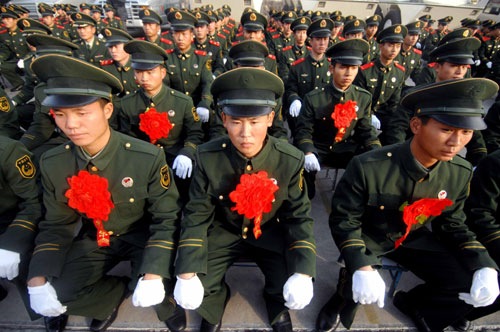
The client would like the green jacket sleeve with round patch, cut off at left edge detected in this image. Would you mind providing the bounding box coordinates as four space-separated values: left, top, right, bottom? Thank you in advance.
0 136 42 254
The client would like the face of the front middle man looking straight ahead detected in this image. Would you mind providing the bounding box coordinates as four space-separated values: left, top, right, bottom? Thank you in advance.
222 111 274 158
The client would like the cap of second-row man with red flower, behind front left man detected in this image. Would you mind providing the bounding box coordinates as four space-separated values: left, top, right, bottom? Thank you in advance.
123 40 168 70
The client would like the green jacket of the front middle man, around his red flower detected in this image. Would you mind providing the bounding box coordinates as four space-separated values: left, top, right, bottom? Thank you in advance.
175 137 316 277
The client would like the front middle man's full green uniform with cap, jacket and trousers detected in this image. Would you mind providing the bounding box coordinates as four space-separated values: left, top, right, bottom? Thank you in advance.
175 68 316 328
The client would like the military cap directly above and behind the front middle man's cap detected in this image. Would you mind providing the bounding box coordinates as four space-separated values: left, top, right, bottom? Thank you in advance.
229 40 269 67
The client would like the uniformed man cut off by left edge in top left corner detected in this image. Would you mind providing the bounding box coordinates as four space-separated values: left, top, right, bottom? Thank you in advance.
0 7 29 92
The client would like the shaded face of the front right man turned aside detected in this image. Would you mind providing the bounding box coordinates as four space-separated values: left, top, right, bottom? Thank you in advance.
410 117 474 167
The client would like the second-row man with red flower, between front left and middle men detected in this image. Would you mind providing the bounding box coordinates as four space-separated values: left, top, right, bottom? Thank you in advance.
119 40 203 202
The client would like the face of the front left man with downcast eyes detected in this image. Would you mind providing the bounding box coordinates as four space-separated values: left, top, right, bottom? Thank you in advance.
53 100 113 155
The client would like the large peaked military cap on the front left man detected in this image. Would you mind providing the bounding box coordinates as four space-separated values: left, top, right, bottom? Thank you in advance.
31 54 123 107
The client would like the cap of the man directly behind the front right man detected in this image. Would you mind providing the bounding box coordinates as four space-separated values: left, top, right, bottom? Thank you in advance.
429 37 481 65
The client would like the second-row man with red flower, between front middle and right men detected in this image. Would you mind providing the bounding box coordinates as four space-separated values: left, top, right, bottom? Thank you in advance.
294 39 380 199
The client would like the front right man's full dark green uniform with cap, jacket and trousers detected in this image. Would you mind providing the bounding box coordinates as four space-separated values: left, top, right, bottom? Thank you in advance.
317 79 498 331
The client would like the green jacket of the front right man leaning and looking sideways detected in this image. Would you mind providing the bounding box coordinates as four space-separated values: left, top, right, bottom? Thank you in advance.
329 141 497 274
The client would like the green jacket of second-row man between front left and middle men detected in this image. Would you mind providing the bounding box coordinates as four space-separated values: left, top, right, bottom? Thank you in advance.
119 85 203 162
